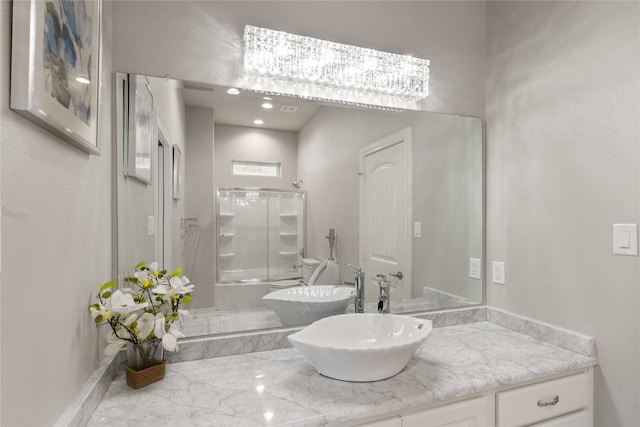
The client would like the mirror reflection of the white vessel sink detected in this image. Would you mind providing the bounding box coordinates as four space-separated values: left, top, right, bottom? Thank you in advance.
262 286 355 326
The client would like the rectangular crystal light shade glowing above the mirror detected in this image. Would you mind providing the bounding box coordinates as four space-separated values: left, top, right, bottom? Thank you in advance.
244 25 429 100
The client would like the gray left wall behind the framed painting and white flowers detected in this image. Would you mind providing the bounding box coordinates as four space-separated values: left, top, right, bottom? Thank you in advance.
0 1 113 426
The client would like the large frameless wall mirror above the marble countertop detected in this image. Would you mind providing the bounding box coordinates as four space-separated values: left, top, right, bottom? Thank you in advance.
117 75 484 336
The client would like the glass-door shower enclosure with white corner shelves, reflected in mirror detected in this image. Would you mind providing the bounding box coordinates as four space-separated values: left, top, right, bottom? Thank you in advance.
216 188 306 283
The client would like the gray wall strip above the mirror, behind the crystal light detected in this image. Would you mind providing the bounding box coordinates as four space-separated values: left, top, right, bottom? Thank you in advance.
113 1 486 116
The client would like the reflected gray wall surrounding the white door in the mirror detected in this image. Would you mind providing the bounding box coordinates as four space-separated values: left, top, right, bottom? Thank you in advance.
298 107 482 301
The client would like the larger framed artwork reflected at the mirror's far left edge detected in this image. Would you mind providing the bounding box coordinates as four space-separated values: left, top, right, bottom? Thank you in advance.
125 74 155 184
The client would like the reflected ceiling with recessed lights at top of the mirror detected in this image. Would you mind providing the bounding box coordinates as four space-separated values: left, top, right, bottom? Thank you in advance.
183 82 320 132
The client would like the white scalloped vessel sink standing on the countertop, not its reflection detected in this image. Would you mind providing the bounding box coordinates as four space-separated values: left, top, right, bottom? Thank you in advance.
289 313 432 381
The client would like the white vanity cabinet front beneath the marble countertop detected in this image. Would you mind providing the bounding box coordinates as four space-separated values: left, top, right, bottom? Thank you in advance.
360 369 593 427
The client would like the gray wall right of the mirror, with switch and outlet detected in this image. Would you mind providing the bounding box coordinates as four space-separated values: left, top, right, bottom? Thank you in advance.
486 2 640 427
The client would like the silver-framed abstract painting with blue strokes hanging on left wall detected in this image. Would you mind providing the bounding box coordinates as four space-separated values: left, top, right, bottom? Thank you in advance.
11 0 102 155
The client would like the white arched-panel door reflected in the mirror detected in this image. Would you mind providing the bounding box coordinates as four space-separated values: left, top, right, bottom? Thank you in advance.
360 128 411 300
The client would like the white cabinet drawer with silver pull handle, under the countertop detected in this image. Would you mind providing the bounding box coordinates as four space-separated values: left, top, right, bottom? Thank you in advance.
496 373 591 427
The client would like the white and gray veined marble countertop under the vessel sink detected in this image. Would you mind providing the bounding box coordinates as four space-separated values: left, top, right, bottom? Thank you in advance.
88 321 597 427
